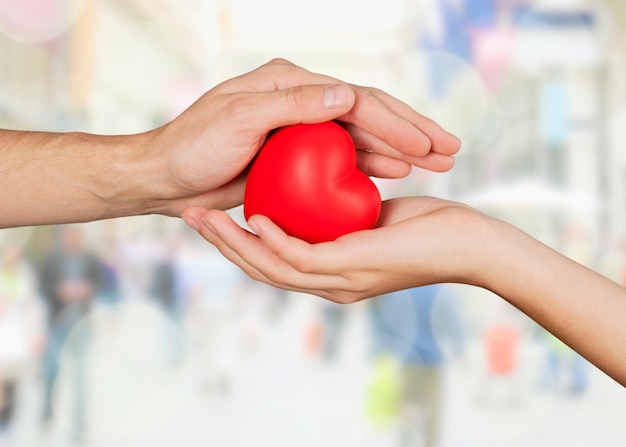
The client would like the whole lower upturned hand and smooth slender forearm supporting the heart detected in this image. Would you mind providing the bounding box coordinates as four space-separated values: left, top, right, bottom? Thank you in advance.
183 197 626 386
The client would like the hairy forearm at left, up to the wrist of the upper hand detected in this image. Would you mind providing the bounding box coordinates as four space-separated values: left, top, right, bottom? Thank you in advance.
0 130 166 228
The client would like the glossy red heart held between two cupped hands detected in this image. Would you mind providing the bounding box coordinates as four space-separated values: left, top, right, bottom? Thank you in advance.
243 121 381 243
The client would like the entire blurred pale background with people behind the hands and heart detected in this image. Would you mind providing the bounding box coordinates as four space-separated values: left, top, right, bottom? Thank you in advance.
0 0 626 447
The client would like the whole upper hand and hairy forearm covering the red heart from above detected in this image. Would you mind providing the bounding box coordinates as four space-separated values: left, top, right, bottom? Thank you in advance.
0 59 460 228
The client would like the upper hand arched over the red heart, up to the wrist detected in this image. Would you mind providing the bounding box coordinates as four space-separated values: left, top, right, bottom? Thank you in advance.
149 59 460 215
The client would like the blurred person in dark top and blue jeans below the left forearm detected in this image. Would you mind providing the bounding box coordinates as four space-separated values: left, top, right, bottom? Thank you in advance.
38 225 105 440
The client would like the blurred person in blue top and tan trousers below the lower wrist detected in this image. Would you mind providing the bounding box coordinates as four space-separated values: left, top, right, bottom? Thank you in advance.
370 285 463 447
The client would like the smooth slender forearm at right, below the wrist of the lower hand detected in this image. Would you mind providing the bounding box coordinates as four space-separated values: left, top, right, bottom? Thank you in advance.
483 217 626 386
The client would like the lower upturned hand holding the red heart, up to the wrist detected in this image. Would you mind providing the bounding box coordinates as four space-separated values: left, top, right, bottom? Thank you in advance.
183 197 487 303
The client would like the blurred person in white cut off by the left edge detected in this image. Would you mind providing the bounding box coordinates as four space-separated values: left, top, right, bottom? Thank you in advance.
0 242 43 446
